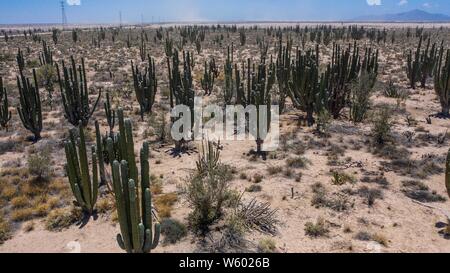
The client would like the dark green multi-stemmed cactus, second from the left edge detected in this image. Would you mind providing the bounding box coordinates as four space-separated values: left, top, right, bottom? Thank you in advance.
17 69 42 141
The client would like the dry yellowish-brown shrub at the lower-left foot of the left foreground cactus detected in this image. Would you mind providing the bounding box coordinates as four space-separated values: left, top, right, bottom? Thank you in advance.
45 207 83 231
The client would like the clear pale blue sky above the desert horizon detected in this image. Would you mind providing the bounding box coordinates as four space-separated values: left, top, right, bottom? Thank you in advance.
0 0 450 24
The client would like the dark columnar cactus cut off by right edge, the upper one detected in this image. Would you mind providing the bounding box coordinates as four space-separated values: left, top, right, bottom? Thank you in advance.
434 46 450 117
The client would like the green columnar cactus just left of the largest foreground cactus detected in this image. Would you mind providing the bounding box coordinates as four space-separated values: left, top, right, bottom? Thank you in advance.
64 124 99 214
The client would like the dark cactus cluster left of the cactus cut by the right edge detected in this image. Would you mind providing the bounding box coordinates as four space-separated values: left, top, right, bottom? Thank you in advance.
406 36 438 89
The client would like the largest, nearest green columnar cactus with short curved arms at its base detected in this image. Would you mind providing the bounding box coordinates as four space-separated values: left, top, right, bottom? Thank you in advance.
112 142 160 253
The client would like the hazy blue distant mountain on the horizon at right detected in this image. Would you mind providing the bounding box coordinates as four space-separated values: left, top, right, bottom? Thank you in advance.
351 9 450 22
